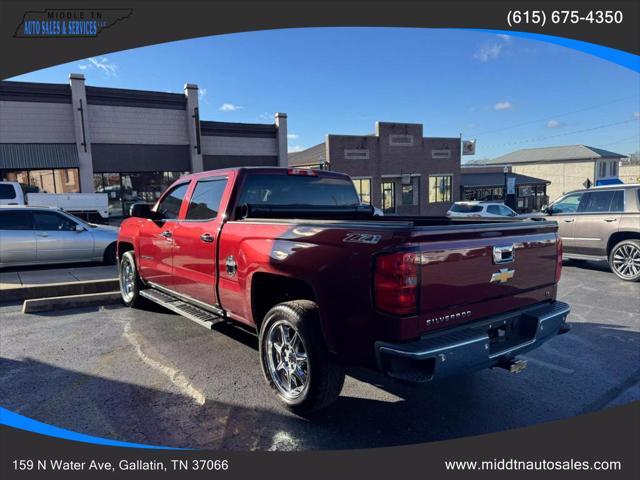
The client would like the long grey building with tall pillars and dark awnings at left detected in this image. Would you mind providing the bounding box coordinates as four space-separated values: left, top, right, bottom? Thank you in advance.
0 74 287 216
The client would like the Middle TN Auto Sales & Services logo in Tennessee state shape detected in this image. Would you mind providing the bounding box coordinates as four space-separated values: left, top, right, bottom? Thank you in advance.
13 8 133 38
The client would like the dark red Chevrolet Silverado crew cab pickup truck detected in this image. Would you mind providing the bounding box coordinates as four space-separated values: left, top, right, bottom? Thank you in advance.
118 168 570 414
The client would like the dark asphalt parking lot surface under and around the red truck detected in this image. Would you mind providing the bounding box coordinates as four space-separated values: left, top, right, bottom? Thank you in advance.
0 263 640 450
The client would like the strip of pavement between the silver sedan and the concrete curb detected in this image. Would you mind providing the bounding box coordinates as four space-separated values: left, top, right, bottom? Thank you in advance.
0 265 118 290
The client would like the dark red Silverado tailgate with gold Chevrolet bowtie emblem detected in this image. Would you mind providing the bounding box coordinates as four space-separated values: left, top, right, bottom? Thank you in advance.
415 222 557 323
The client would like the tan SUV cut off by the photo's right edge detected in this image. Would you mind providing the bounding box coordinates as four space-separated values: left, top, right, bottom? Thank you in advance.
542 184 640 282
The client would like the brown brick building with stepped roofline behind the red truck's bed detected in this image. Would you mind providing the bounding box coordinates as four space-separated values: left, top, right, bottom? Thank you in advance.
289 122 461 215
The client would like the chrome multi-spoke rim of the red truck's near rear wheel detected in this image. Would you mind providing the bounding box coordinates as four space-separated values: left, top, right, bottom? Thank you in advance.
265 320 311 400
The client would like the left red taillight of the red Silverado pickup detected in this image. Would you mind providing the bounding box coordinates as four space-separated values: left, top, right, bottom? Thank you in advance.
373 252 418 315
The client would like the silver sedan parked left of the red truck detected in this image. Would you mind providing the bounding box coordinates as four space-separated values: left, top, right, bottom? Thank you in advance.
0 205 118 267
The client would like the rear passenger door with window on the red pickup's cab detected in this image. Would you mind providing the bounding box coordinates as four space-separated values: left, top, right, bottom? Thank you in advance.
173 175 231 306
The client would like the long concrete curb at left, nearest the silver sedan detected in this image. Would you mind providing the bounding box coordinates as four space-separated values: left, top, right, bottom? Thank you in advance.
0 278 119 302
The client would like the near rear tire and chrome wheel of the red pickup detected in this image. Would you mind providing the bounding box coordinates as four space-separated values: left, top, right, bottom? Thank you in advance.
260 300 345 415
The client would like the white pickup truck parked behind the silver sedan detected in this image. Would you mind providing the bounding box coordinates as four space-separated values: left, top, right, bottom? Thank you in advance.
0 182 109 223
